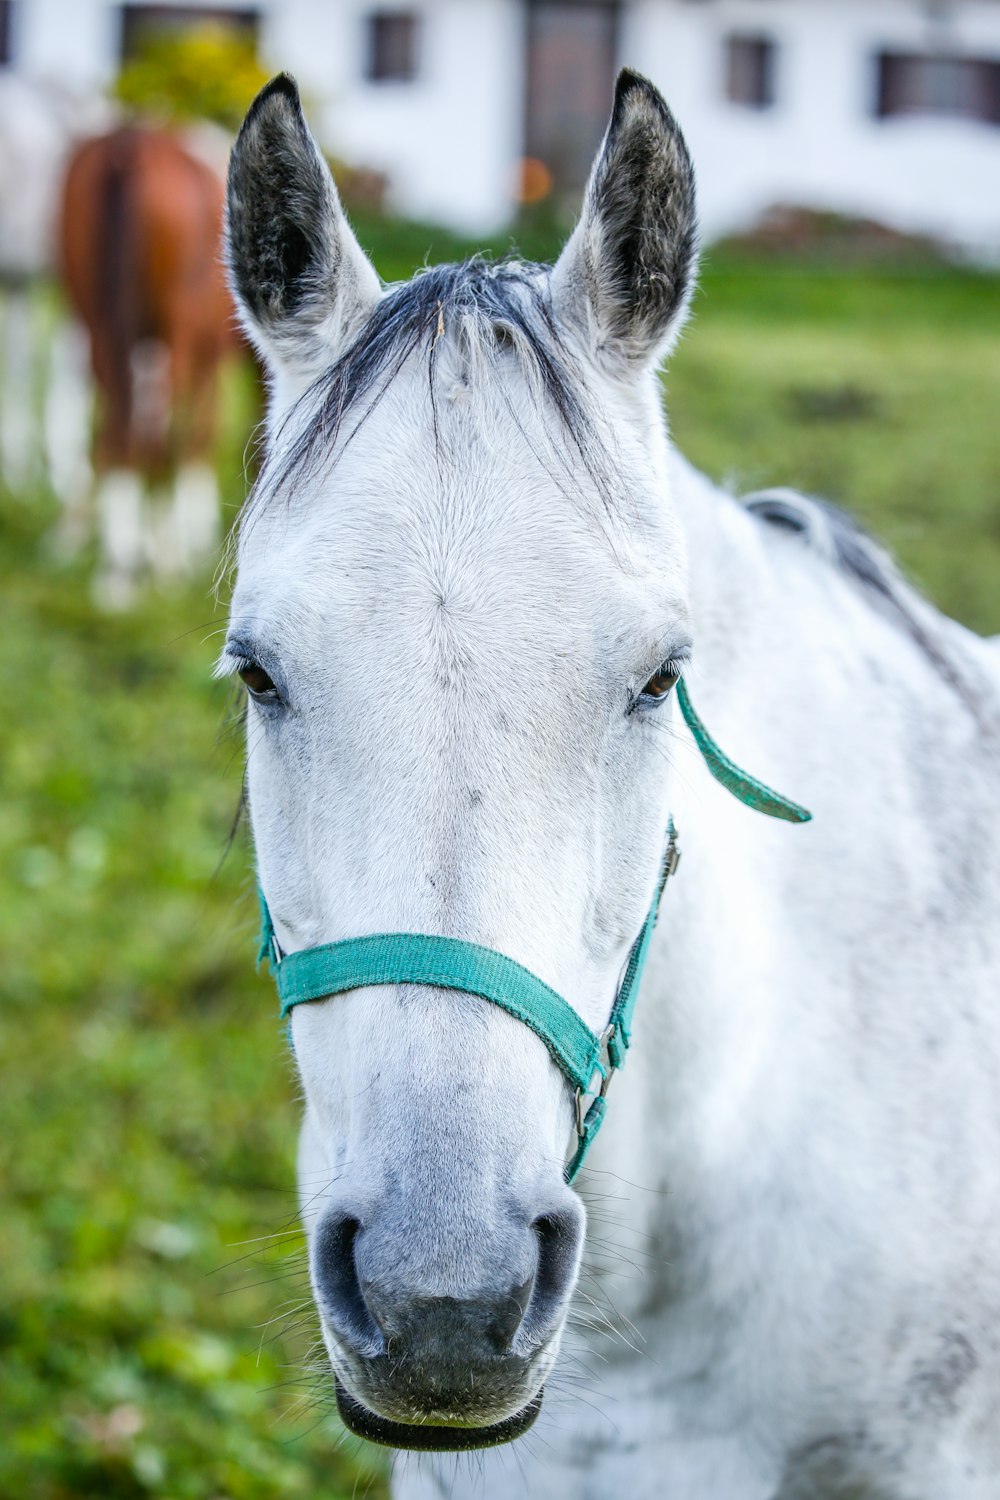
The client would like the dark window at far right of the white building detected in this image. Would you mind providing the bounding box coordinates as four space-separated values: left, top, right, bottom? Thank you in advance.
876 53 1000 125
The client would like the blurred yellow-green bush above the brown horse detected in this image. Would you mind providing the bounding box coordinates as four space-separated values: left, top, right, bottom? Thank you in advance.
114 24 268 131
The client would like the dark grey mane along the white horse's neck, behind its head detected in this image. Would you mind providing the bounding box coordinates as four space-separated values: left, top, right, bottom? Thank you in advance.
742 488 982 713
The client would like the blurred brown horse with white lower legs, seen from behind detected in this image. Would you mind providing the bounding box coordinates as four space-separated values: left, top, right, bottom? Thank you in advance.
60 125 240 605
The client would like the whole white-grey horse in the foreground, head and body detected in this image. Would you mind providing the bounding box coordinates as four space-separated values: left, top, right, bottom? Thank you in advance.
220 74 1000 1500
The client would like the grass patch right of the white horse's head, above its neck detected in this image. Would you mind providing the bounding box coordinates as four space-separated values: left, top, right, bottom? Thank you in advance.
666 261 1000 633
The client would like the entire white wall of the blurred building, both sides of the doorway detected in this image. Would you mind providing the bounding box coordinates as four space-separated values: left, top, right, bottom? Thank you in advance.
7 0 1000 257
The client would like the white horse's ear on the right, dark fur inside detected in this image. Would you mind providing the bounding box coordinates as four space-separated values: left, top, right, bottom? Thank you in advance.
552 69 697 372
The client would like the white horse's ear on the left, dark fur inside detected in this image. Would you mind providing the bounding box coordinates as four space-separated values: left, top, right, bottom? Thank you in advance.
226 74 381 407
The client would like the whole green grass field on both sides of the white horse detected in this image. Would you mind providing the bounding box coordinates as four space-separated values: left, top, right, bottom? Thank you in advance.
0 227 1000 1500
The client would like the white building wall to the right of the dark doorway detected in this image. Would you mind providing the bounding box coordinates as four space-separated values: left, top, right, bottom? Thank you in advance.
622 0 1000 257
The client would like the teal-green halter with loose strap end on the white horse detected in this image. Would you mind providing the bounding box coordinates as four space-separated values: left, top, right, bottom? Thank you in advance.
259 681 811 1182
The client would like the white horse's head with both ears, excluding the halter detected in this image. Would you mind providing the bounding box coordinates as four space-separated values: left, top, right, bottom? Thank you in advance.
223 74 694 1446
